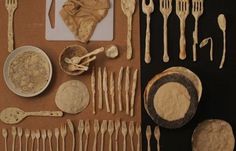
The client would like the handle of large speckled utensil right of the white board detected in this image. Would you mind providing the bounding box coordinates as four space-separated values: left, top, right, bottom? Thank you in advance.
127 16 133 60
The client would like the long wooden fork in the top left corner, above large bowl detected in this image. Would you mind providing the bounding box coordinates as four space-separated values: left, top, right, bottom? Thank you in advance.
5 0 17 52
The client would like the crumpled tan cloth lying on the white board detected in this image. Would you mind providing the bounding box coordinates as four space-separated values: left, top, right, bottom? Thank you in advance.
60 0 110 43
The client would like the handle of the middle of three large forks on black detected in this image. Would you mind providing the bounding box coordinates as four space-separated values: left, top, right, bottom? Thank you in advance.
179 19 186 60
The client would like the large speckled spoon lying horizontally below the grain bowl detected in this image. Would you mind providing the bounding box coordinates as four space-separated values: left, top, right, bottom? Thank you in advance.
0 107 63 124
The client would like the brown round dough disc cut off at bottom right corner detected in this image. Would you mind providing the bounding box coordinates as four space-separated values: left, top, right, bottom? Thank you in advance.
192 119 235 151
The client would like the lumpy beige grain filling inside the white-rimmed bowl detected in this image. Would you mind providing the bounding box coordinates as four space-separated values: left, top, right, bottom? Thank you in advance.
9 51 50 94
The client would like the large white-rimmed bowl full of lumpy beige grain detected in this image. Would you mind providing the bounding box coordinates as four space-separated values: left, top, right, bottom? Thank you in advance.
3 46 52 97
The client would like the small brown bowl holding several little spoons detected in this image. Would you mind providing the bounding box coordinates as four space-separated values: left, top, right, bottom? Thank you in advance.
59 45 89 76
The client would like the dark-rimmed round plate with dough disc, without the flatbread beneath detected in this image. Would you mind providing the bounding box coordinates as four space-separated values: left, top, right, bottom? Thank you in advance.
147 73 198 129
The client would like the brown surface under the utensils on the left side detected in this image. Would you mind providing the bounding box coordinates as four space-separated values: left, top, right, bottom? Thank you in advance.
0 0 141 150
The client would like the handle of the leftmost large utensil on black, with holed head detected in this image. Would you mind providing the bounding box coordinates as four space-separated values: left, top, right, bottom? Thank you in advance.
145 14 151 64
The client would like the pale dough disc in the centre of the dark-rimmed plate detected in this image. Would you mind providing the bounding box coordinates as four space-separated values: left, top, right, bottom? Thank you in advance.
153 82 190 121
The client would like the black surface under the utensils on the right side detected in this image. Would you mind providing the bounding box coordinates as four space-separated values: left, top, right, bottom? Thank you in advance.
141 0 236 151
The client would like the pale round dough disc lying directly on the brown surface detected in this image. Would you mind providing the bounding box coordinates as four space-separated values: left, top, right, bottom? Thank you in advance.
55 80 89 114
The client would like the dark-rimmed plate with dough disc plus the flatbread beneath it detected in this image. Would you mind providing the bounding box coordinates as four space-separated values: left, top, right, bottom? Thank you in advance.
144 67 202 128
